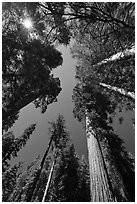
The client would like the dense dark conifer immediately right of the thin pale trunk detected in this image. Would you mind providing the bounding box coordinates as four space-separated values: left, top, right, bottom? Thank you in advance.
49 145 79 202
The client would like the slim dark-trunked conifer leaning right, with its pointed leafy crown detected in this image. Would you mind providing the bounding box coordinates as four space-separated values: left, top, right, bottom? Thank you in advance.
18 115 68 202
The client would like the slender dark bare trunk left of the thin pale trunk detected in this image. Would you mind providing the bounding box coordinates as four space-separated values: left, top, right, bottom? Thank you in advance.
27 135 54 202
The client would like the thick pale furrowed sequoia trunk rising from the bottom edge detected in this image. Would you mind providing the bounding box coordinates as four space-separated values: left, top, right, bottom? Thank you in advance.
86 112 117 202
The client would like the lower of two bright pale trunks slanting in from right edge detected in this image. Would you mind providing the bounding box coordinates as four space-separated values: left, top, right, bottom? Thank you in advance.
99 83 135 100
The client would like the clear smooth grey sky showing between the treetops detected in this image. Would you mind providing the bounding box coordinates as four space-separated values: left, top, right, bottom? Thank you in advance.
11 46 135 166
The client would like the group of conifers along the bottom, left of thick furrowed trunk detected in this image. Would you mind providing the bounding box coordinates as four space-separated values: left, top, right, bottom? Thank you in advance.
3 115 90 202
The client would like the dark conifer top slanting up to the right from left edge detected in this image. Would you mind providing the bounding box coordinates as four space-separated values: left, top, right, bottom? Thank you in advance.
2 124 36 171
